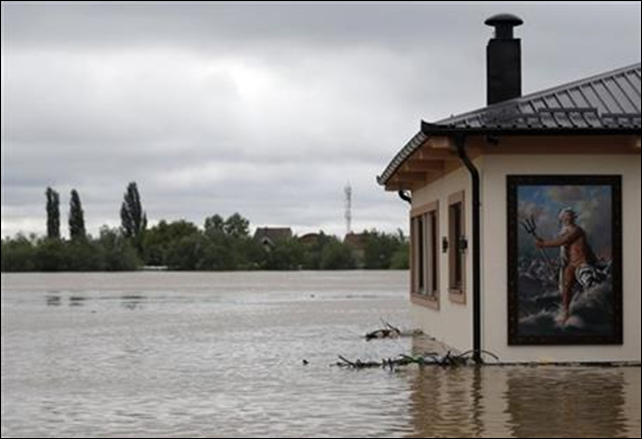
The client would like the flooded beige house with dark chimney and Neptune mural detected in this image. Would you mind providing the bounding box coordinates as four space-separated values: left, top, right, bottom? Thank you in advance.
378 14 642 363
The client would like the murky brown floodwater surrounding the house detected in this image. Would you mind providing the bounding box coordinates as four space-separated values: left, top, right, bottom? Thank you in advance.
2 272 640 438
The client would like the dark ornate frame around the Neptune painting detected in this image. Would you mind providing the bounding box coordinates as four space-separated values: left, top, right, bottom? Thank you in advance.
507 175 624 346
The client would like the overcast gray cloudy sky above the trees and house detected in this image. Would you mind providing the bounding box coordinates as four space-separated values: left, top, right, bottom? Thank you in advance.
2 2 641 241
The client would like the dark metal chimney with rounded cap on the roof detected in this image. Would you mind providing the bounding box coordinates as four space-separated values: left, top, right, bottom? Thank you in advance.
485 14 524 105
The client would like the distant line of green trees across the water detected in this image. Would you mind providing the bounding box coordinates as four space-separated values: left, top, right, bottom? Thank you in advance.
2 183 409 272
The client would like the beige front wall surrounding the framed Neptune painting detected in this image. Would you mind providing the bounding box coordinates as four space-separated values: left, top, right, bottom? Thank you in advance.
482 155 642 362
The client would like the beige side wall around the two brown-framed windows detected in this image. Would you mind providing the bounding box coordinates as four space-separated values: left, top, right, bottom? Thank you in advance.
411 160 481 352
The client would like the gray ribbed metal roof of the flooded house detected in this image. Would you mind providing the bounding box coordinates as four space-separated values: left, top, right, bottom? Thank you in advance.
377 63 641 185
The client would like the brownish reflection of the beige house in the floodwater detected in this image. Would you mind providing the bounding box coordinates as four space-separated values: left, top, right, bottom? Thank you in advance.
408 350 639 437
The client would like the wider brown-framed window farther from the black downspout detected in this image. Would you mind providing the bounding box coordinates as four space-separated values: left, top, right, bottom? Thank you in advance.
411 203 440 309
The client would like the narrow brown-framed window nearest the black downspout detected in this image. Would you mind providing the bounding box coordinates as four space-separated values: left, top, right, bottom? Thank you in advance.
448 192 467 303
